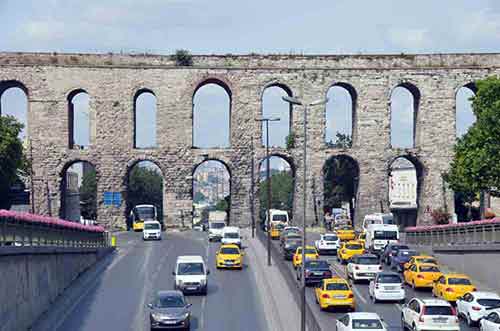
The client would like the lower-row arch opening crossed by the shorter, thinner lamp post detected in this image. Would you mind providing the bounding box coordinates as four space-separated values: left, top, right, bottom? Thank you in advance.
258 155 295 225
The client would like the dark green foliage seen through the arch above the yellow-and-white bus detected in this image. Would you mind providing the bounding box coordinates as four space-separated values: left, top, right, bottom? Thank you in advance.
127 166 163 220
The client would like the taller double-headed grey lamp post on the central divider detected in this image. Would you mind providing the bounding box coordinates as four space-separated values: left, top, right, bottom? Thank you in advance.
281 96 328 331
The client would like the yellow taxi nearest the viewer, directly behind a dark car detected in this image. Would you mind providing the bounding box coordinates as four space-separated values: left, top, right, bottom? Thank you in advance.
314 277 356 311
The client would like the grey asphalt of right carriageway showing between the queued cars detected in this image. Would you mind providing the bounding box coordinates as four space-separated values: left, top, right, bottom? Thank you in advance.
273 233 479 331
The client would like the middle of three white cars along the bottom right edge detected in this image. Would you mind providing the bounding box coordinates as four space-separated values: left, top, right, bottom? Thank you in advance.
401 298 460 331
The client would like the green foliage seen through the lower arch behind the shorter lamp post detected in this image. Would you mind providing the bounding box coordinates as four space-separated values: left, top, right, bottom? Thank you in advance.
259 171 293 219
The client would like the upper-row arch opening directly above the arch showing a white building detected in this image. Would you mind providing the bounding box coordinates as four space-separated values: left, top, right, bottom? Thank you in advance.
389 82 421 148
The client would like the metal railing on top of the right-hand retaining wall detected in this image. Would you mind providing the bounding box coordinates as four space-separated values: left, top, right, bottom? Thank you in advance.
405 218 500 247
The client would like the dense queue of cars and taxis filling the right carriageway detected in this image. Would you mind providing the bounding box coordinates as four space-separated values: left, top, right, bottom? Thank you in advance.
276 215 500 331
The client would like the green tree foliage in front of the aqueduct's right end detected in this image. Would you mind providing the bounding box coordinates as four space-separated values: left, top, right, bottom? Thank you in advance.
444 77 500 201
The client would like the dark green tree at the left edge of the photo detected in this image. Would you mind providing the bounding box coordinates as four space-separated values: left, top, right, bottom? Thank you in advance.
0 116 29 209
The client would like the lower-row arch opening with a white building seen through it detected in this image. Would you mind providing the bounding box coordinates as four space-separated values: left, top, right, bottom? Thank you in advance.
388 156 423 229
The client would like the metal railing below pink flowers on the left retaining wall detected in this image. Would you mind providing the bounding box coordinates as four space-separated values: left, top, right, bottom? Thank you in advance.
0 217 111 248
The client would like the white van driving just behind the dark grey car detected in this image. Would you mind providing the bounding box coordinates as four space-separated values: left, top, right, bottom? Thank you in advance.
172 255 210 294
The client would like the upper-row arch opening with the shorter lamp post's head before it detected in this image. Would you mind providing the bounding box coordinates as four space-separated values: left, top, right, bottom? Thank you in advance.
260 81 293 147
